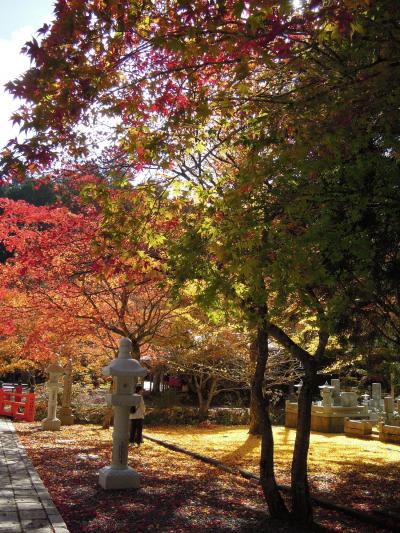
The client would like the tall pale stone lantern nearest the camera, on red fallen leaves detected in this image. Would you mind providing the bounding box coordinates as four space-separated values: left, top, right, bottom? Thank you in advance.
99 338 147 489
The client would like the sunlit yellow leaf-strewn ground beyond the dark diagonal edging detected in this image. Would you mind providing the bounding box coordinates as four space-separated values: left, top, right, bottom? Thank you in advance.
147 426 400 512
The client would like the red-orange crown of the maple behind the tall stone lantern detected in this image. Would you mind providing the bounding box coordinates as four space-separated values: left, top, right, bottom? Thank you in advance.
0 183 184 374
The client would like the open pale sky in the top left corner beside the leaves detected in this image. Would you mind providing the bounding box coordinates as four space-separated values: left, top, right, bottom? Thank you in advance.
0 0 54 150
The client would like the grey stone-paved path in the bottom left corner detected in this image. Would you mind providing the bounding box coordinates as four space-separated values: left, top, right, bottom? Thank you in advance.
0 417 68 533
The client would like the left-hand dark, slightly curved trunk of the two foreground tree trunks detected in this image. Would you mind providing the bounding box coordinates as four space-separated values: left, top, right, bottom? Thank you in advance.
252 314 289 520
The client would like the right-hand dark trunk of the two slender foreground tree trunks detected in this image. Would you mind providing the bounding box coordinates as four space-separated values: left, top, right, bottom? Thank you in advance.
291 362 316 525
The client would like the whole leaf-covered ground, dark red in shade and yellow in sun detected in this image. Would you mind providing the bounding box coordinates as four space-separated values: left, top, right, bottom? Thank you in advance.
16 423 400 533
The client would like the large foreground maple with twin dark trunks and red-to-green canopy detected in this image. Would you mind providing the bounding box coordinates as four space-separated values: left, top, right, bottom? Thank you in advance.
3 0 399 522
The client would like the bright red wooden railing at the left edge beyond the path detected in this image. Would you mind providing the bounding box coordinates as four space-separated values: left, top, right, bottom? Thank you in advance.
0 384 35 422
